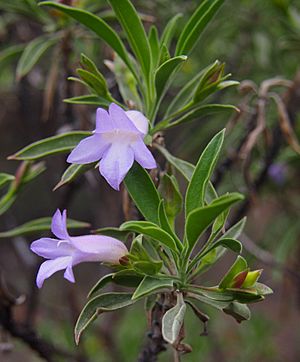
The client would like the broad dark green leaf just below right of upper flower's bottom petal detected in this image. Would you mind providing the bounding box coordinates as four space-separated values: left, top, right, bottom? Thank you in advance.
124 162 160 225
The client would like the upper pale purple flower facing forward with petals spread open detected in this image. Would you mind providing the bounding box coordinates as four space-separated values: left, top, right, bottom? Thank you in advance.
67 103 156 190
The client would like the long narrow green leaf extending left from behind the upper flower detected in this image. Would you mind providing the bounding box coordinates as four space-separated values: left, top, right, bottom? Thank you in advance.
8 131 91 160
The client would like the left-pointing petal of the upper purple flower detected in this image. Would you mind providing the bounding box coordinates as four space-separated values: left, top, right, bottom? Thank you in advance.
67 133 109 164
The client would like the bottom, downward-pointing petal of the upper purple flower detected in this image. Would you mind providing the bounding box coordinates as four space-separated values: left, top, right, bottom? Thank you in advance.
99 143 134 191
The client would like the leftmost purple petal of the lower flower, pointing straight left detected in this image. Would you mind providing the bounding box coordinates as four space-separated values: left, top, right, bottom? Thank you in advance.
30 238 73 259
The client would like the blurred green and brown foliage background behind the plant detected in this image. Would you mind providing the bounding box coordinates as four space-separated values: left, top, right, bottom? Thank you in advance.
0 0 300 362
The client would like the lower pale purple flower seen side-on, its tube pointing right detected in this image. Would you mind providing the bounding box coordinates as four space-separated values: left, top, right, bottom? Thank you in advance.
30 210 128 288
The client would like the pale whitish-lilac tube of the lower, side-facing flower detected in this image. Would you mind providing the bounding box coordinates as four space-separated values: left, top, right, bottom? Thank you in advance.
71 235 128 265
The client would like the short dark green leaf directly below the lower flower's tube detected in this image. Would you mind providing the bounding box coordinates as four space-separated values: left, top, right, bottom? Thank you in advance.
88 270 143 298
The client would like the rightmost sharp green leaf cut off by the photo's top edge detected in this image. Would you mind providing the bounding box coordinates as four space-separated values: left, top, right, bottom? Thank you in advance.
175 0 224 55
